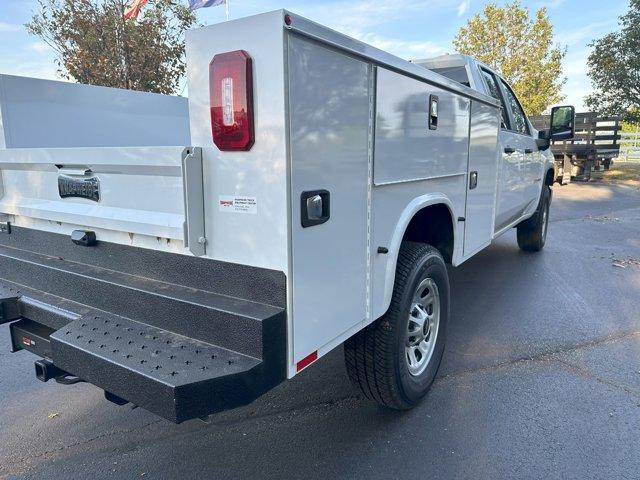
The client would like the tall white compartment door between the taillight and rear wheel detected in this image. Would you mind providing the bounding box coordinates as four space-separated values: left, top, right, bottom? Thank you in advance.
288 35 371 363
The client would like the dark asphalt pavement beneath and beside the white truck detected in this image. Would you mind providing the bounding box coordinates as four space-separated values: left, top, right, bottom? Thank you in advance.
0 178 640 480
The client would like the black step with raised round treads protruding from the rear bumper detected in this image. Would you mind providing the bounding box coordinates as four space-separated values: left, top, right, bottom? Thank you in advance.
51 314 262 423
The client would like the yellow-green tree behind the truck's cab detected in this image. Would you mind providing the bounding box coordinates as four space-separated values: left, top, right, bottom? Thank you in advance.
453 0 566 115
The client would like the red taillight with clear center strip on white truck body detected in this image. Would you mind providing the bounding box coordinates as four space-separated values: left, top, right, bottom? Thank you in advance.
209 50 254 151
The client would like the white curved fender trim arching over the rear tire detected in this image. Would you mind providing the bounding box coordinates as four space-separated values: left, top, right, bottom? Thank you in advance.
380 193 458 314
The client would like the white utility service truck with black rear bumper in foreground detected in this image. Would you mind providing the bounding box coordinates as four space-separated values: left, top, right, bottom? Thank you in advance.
0 11 573 422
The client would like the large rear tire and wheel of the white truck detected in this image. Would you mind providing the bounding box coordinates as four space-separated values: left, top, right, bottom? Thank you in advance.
344 242 449 410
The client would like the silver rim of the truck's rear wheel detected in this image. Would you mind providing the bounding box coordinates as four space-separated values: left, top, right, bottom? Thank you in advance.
405 278 440 376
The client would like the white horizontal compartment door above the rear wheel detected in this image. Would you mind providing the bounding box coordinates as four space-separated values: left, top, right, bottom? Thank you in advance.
374 68 470 185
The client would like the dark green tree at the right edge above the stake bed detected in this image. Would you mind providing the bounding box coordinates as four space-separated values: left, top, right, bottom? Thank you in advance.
586 0 640 124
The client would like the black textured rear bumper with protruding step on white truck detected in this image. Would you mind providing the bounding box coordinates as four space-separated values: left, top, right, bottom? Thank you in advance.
0 228 286 423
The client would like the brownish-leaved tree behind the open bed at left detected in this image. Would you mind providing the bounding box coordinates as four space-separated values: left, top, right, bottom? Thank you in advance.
26 0 196 94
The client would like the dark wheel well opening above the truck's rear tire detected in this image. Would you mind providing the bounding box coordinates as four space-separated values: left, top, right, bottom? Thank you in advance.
402 203 453 263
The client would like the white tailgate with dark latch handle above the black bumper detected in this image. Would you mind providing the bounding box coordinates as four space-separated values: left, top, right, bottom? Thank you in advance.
0 147 184 240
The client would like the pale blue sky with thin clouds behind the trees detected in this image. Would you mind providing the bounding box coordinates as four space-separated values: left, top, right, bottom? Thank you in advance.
0 0 627 111
